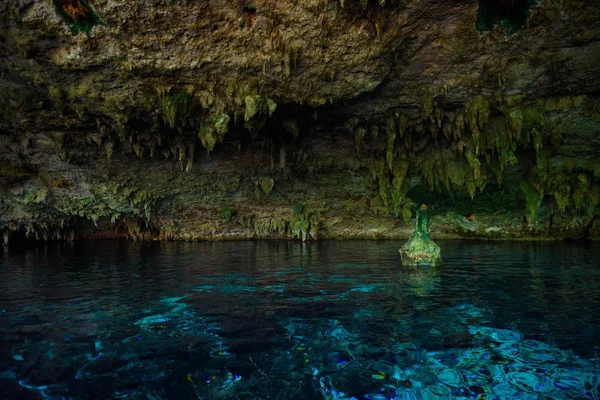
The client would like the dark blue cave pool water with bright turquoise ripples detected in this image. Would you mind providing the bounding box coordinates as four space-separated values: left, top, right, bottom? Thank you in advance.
0 241 600 399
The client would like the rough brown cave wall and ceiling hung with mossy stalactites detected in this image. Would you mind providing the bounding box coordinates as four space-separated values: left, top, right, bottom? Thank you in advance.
0 0 600 241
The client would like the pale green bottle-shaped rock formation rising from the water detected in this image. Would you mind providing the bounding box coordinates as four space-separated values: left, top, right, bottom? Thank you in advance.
399 204 444 267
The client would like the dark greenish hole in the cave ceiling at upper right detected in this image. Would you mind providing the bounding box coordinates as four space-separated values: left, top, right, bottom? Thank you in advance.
476 0 536 36
